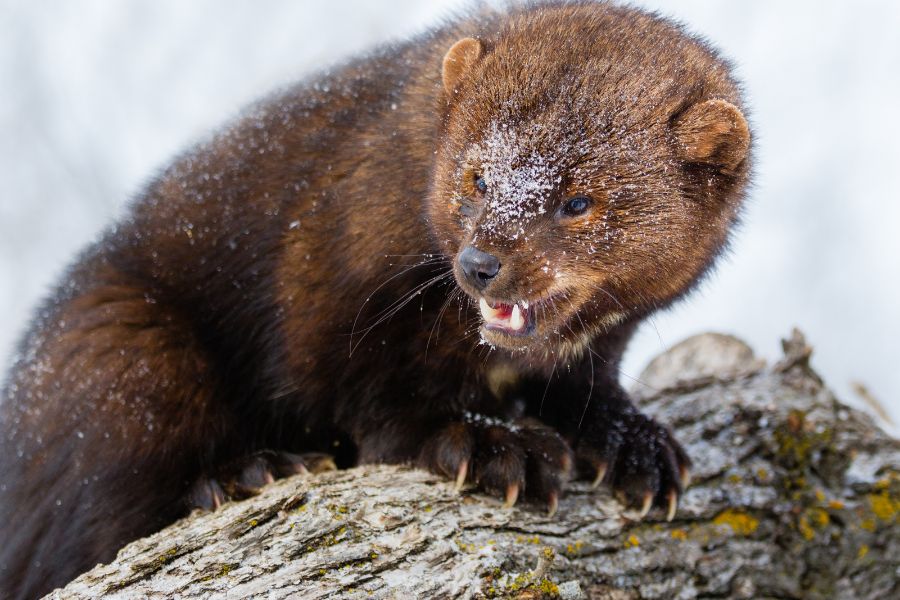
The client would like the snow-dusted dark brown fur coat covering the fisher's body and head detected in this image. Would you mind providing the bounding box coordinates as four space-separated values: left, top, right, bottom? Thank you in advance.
0 2 749 598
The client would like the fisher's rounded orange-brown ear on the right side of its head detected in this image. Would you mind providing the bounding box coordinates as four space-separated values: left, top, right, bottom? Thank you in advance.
672 100 750 173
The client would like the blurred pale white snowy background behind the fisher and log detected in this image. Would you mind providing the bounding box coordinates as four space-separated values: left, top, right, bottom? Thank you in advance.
0 0 900 428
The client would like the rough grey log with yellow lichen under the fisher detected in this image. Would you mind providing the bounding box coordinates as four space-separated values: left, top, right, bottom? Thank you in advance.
50 332 900 599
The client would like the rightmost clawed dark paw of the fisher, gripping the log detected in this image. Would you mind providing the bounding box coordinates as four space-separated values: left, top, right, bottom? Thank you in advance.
576 412 691 521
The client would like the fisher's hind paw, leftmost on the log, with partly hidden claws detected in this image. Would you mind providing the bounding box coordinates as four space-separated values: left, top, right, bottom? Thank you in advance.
185 450 336 510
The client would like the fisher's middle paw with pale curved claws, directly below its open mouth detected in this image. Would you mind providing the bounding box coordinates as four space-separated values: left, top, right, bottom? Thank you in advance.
418 414 573 514
